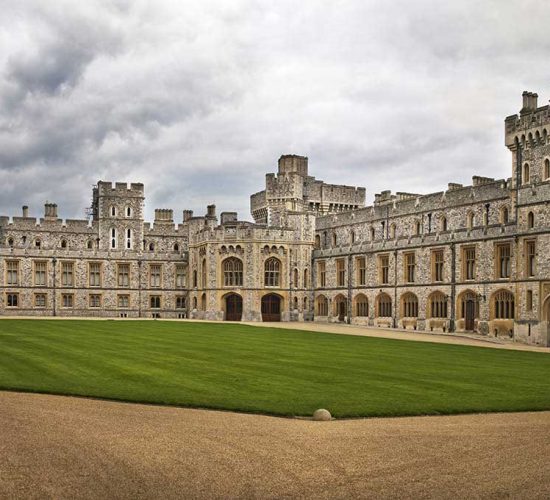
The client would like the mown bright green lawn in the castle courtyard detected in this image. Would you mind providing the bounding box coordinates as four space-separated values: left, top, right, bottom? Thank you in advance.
0 320 550 417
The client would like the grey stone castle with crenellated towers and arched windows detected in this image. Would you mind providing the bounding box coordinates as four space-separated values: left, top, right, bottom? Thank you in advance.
0 92 550 345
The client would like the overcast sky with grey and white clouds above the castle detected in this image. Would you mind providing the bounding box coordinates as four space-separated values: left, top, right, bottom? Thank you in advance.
0 0 550 220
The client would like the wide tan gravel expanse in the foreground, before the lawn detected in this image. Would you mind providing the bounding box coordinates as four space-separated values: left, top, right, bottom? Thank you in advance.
0 392 550 499
